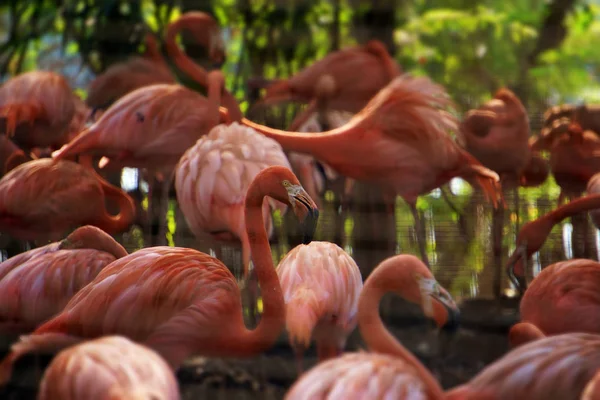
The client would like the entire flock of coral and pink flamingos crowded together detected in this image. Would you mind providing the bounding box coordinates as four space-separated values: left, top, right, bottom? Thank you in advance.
0 7 600 400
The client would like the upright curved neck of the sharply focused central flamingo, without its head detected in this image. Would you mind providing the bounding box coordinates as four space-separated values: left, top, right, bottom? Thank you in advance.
227 174 285 356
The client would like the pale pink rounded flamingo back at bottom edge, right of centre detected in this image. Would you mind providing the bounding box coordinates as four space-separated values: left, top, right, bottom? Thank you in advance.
285 352 429 400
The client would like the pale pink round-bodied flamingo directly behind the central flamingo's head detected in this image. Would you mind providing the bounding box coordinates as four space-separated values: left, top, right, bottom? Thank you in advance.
175 122 291 276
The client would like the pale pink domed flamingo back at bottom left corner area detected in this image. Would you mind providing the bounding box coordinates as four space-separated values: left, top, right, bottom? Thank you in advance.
38 336 180 400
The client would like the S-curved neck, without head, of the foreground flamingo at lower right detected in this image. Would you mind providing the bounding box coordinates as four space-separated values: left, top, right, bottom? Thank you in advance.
358 264 444 399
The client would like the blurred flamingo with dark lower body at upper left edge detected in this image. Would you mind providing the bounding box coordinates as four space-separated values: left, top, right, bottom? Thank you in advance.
0 71 83 151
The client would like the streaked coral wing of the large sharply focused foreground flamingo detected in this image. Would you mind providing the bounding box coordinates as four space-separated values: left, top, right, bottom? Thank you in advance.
35 247 240 341
